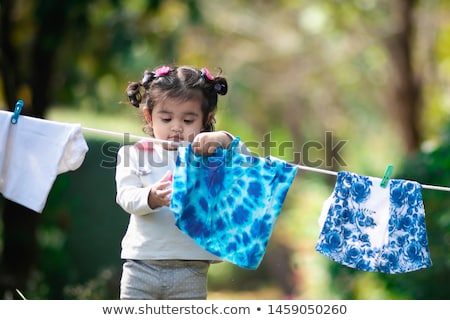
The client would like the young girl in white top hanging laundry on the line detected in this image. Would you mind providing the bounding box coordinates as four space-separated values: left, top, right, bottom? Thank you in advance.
116 66 237 299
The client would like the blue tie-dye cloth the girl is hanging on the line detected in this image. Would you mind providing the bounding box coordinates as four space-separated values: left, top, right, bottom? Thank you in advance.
170 138 297 269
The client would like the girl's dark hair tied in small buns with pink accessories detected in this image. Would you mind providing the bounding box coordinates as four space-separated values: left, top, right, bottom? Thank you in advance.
126 66 228 131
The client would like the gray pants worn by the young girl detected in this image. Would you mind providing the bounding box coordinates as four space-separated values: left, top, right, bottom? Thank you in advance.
120 260 209 300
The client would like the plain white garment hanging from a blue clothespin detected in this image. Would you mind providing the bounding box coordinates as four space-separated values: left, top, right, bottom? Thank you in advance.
0 111 88 213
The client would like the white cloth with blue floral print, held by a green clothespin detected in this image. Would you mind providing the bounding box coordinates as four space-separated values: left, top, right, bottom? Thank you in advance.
315 171 431 274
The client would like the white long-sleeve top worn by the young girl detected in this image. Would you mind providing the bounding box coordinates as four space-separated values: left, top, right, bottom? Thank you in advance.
116 142 220 261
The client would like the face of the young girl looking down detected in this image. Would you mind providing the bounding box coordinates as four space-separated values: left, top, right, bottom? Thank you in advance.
149 98 203 149
